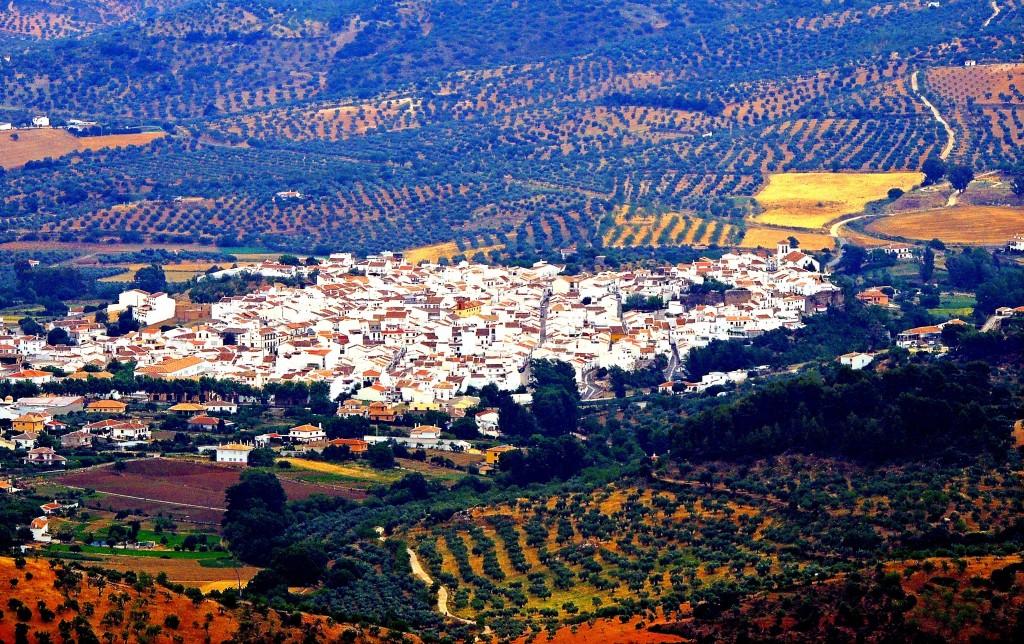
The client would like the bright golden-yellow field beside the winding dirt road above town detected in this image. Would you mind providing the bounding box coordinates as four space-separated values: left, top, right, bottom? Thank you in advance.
756 172 924 228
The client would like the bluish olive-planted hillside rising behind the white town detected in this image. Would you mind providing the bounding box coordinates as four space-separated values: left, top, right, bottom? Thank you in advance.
0 0 1024 256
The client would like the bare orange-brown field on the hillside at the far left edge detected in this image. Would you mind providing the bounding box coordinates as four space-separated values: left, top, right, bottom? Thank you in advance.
0 128 164 169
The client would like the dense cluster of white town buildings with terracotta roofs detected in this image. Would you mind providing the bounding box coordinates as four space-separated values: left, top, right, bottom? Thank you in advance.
0 242 839 403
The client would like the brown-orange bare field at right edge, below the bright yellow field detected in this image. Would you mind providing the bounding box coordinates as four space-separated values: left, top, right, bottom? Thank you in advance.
867 206 1024 244
